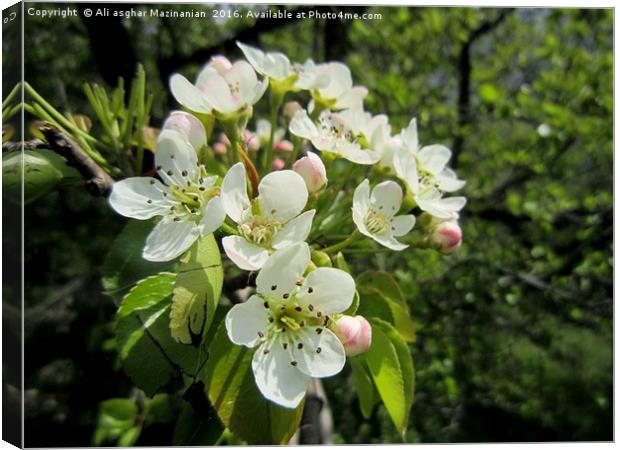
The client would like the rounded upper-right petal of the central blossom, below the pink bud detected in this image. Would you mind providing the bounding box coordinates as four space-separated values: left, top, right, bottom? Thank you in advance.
258 170 308 222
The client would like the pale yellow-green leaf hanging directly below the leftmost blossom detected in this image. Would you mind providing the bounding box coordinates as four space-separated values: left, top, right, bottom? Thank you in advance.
170 234 224 344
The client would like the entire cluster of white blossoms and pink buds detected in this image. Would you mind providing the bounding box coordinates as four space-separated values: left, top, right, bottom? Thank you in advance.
109 43 465 407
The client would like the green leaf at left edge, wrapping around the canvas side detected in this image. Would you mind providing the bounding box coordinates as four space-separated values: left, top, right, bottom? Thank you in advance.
2 149 80 204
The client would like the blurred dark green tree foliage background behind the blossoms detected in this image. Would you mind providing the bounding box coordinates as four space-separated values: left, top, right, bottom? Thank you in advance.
3 3 613 446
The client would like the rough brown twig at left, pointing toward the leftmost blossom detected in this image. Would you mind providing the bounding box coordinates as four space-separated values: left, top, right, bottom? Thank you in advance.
39 123 114 196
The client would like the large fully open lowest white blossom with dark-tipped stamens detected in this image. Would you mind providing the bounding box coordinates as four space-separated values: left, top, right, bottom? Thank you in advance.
225 242 355 408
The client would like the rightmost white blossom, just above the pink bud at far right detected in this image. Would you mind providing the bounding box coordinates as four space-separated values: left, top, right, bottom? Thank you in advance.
393 119 466 219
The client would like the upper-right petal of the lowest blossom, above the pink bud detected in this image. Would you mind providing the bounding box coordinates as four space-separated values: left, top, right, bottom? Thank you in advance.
297 267 355 314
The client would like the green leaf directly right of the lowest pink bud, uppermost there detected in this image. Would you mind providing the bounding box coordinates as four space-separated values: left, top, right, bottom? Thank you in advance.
356 271 415 342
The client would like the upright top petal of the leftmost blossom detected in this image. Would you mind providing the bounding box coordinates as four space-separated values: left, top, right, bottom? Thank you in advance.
155 130 198 186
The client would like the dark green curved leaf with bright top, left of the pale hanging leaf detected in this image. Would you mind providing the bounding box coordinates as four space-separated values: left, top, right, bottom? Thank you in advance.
115 273 200 396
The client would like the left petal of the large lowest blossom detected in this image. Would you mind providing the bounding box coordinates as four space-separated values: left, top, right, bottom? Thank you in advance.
225 295 269 348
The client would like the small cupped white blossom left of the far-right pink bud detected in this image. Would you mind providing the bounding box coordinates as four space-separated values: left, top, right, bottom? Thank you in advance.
352 179 415 251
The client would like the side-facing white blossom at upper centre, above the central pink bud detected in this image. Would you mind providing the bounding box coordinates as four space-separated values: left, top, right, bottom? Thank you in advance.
289 110 380 165
